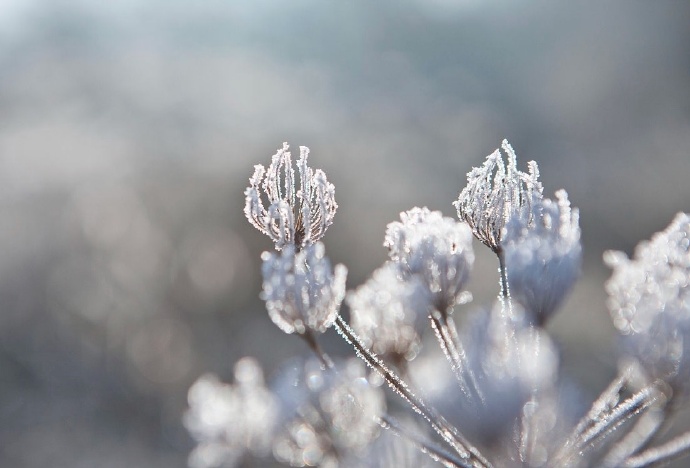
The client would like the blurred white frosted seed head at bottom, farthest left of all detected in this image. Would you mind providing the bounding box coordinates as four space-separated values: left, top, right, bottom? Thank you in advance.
184 358 278 468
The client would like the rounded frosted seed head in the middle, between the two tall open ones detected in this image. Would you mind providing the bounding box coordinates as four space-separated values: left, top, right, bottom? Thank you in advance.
383 208 474 313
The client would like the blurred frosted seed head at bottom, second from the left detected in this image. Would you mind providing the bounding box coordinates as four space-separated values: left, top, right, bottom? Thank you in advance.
273 358 386 466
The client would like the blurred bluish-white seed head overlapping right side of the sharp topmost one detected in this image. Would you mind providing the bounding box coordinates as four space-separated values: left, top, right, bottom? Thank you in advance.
503 190 582 324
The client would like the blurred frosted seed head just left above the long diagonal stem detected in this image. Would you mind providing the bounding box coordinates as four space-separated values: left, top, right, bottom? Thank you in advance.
347 263 428 360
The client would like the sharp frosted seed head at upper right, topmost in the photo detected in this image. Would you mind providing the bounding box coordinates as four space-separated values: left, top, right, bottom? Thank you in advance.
453 140 543 254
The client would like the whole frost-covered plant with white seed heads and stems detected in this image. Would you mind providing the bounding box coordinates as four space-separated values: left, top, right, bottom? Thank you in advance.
185 141 690 468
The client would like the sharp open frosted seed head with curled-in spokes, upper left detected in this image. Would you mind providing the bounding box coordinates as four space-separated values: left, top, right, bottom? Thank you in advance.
244 143 338 250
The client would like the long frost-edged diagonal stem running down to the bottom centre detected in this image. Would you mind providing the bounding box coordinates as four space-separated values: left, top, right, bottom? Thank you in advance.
334 314 491 467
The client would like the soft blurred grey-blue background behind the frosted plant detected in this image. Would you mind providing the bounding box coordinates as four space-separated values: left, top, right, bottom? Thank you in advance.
0 0 690 467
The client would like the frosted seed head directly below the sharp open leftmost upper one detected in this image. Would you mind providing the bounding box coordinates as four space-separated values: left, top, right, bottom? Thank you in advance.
261 242 347 334
